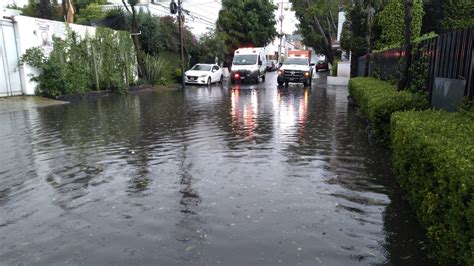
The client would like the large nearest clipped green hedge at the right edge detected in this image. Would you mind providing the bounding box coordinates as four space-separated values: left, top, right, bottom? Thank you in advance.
391 111 474 265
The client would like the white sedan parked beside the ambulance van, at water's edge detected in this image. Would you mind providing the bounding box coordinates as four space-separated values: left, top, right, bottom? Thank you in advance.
184 64 224 86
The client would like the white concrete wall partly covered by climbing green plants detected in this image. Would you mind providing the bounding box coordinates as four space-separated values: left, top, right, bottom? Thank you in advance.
13 16 95 95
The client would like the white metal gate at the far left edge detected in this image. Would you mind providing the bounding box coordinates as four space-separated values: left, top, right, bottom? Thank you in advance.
0 20 23 97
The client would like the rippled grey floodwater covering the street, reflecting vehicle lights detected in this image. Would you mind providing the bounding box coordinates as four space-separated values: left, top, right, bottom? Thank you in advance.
0 73 432 265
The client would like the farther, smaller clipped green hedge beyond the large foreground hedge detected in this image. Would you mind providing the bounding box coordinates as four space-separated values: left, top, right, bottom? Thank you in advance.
349 77 428 144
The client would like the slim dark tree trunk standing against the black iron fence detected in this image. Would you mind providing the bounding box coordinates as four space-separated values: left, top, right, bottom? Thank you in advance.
398 0 413 90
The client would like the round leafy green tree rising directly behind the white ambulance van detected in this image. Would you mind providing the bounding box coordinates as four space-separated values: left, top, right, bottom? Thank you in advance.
216 0 277 64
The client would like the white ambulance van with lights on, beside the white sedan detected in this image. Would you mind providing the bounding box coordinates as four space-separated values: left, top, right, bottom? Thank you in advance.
230 47 267 83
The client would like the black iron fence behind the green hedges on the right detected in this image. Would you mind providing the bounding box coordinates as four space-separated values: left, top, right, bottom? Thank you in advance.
357 25 474 100
